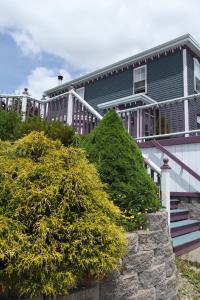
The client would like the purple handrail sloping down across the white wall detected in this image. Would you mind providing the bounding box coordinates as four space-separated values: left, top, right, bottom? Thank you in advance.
151 140 200 181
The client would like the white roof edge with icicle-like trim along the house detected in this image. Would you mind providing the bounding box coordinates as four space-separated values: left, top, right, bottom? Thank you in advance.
44 33 200 95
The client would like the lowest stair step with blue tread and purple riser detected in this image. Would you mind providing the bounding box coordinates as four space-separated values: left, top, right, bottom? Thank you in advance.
172 230 200 256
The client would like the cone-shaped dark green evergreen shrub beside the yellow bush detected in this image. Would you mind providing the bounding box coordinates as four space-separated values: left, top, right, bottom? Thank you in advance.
83 110 160 229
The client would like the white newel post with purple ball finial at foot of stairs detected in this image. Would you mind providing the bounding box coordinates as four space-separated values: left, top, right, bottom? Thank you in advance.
161 158 171 228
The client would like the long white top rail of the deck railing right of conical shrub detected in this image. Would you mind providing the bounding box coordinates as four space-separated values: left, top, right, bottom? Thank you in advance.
117 93 200 114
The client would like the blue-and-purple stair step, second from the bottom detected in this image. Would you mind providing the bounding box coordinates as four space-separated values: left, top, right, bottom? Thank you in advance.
170 220 200 237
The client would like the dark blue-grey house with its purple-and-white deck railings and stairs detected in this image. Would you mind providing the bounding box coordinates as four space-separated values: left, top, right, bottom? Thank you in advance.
0 34 200 255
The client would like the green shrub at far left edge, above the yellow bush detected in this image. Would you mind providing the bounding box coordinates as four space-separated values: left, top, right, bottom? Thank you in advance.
0 110 20 141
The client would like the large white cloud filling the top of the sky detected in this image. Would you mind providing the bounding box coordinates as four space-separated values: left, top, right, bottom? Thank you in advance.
0 0 200 71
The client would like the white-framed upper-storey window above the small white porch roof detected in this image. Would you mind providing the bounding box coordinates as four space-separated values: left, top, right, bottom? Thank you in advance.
133 65 147 94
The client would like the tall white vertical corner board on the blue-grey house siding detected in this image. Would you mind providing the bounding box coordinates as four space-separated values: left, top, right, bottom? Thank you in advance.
183 49 189 136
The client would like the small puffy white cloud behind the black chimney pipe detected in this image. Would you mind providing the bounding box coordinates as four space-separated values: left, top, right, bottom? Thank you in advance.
15 67 71 99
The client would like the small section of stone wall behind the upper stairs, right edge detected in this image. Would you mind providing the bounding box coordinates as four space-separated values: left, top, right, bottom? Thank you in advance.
178 197 200 220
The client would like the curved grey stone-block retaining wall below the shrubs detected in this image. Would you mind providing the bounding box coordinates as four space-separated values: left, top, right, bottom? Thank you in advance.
0 212 177 300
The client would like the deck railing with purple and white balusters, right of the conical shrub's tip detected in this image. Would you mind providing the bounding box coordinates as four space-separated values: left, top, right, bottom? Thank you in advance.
117 93 200 141
